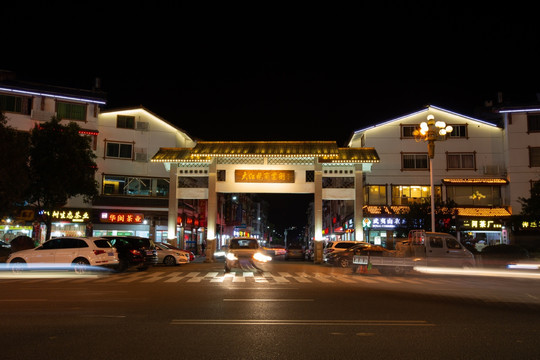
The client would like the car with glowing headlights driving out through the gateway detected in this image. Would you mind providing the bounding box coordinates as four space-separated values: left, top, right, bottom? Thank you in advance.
225 237 272 272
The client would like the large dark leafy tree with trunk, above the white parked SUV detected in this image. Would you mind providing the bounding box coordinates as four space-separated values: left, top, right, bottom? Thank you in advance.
30 117 98 240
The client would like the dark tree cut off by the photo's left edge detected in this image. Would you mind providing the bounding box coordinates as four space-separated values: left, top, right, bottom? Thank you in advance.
0 112 30 218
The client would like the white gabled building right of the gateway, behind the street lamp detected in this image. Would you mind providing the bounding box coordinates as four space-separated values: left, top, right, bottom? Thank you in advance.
349 106 511 248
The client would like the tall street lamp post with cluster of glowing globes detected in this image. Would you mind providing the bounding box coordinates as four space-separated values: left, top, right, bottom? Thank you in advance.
414 114 452 232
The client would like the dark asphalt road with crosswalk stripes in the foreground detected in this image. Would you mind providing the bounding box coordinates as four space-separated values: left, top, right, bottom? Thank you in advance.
0 261 540 360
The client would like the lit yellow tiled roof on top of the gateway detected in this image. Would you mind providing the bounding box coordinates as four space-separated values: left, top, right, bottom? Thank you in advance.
152 141 379 163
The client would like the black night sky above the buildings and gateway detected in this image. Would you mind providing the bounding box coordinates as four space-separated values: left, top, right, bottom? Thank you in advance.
0 1 540 231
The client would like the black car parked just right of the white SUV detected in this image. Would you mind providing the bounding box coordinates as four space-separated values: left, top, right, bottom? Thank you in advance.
101 235 158 271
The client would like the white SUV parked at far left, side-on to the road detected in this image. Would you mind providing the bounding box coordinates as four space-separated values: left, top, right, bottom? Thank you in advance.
7 237 119 274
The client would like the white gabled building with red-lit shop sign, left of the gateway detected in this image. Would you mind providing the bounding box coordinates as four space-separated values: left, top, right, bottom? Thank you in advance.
88 107 199 247
